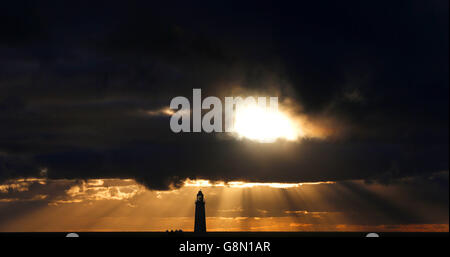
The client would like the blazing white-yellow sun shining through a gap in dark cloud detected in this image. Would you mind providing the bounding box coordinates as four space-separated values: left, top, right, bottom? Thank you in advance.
233 105 302 143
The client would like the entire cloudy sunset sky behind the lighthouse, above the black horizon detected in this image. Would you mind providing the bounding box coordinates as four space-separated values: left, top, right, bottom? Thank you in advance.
0 0 449 231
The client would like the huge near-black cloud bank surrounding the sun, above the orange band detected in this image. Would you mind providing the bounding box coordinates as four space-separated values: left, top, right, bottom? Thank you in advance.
0 1 449 189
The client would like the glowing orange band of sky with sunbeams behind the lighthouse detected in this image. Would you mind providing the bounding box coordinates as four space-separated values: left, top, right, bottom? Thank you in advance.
0 178 449 232
